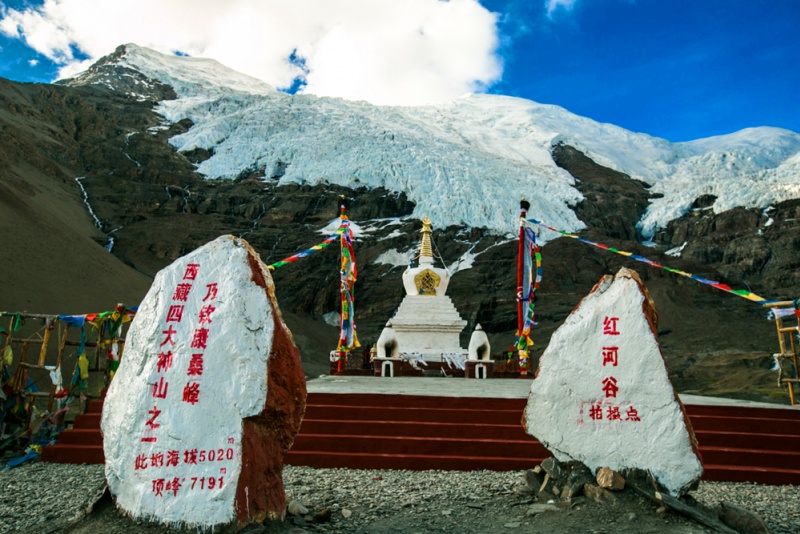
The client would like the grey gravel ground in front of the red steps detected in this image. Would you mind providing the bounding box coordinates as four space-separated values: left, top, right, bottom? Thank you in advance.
0 462 800 534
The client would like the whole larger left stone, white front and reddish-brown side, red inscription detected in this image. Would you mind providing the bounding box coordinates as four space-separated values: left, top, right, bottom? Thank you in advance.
102 236 306 529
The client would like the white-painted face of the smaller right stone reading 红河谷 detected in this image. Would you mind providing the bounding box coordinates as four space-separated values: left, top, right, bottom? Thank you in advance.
524 268 703 494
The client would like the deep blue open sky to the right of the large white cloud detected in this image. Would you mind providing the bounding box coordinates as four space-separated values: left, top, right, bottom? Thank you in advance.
485 0 800 141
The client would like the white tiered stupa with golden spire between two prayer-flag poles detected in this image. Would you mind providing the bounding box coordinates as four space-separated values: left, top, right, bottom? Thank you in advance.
378 217 467 360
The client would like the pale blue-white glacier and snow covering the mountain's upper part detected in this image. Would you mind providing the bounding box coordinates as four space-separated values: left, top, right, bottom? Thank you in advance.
68 45 800 243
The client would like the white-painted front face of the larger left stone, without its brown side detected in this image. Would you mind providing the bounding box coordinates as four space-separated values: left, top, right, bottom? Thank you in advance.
102 236 274 526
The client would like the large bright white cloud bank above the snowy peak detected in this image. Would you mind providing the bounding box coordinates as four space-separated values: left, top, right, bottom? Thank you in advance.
0 0 500 105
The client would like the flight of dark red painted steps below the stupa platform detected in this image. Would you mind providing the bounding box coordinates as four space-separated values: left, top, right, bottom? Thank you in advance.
42 393 800 484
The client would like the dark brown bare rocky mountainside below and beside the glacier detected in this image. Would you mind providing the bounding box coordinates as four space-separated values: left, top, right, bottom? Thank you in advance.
0 52 800 402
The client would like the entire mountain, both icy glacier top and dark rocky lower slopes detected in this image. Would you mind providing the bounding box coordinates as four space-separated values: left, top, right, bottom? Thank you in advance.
0 45 800 388
